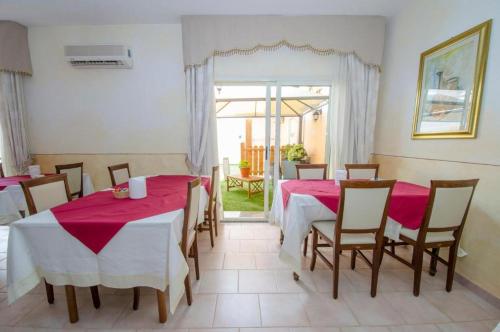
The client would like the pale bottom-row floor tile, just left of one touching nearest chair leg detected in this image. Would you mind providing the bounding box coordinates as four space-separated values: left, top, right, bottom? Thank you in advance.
259 294 310 327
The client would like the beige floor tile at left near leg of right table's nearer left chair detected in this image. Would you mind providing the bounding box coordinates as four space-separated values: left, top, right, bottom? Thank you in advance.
300 293 359 326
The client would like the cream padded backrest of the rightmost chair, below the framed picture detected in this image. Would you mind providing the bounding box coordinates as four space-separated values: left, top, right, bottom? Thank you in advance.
428 186 474 228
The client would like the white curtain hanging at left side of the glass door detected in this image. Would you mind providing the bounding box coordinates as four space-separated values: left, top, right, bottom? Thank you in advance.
186 57 218 175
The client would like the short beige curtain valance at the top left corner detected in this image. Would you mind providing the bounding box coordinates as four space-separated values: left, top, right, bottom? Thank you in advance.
0 21 32 75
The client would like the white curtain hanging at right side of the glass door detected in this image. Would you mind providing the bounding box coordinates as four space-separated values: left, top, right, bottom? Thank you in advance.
328 54 380 172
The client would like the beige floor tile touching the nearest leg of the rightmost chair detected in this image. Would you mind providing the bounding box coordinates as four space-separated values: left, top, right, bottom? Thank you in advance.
379 292 450 324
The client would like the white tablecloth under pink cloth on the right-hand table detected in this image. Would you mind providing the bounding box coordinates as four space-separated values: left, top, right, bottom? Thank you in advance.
269 180 401 274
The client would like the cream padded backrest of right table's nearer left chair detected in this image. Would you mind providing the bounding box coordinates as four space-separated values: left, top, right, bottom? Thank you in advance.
342 187 390 230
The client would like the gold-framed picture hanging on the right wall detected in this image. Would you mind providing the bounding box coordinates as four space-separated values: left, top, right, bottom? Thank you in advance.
412 20 491 139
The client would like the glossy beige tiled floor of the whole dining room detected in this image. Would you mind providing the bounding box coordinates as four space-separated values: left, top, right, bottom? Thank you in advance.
0 223 500 332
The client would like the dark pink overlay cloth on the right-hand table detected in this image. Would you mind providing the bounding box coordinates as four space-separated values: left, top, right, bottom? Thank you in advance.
281 180 429 229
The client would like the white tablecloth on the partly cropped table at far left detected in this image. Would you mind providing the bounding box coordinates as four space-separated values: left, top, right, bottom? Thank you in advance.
0 173 94 225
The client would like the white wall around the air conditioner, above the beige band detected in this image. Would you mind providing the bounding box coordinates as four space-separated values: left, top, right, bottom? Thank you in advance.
26 24 187 154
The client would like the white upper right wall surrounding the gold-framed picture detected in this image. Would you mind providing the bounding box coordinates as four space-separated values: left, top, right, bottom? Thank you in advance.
375 0 500 165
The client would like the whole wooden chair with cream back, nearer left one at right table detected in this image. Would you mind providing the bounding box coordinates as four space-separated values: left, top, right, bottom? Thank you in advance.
311 180 396 299
